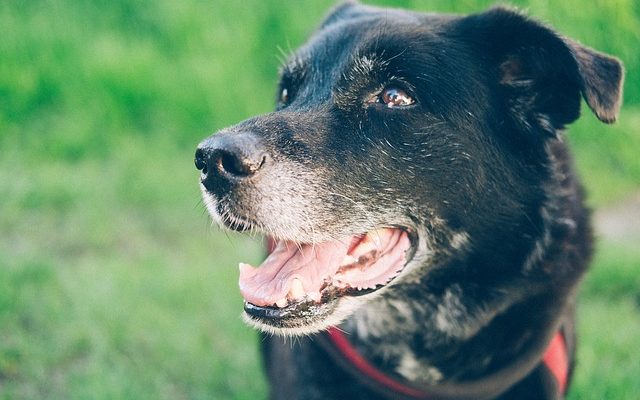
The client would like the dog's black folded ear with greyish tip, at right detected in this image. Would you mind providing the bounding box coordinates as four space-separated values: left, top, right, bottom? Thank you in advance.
460 7 624 134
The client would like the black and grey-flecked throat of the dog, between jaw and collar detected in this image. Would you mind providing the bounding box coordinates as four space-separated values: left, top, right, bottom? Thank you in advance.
341 260 566 387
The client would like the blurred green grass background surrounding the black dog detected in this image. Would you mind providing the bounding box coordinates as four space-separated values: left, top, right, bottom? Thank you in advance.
0 0 640 399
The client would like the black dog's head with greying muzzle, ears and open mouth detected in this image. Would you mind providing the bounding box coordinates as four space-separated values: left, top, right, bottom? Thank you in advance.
196 2 623 334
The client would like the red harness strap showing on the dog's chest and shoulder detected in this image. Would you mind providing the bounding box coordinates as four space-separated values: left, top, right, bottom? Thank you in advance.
327 327 569 399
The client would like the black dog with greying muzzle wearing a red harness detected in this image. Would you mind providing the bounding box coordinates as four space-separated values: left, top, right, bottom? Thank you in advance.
196 2 623 399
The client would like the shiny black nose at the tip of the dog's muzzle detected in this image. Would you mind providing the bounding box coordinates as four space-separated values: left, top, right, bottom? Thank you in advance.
195 132 267 189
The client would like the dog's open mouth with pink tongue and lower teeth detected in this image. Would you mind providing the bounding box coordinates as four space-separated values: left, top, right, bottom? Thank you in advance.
240 228 412 319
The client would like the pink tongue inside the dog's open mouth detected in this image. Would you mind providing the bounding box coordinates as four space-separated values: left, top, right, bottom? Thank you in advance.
239 239 350 306
